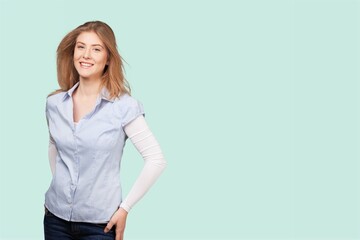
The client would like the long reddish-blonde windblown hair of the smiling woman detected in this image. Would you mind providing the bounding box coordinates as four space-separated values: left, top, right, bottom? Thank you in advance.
49 21 131 99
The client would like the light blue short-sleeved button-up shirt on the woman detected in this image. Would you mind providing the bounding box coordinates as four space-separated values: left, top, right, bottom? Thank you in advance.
45 82 144 223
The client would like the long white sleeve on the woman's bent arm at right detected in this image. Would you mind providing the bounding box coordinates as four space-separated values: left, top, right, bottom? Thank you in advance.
120 116 167 212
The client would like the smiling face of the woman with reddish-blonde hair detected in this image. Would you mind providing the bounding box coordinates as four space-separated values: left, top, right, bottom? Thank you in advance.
74 32 108 80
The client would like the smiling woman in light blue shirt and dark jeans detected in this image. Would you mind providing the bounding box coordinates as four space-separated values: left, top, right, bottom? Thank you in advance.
44 21 166 240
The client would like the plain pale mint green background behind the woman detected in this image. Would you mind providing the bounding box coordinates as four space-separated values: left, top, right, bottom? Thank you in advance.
0 0 360 240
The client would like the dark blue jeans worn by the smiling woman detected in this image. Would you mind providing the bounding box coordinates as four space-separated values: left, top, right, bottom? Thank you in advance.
44 208 115 240
